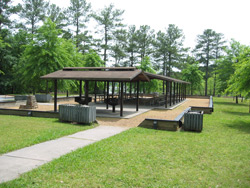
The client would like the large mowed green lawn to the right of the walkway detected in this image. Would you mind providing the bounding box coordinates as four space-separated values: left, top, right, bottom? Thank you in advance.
0 98 250 188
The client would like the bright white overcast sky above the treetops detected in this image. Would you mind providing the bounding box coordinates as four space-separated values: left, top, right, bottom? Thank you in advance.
50 0 250 48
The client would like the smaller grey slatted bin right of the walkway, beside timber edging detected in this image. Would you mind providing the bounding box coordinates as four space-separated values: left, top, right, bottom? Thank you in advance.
183 111 203 132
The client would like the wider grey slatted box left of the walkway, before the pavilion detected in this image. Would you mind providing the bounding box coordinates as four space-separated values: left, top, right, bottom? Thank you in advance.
59 104 96 124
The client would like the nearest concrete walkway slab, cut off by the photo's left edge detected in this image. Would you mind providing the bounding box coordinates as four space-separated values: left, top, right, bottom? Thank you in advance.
0 155 46 183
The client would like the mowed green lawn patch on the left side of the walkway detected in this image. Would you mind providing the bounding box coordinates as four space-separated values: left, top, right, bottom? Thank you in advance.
0 115 93 154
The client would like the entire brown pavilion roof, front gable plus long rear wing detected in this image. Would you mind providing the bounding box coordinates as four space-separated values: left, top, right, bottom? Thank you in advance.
41 67 189 84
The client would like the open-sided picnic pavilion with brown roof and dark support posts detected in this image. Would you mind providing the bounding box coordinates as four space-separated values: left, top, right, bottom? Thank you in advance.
41 67 190 116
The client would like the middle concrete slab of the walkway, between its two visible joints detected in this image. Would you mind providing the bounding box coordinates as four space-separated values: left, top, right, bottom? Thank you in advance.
5 137 94 161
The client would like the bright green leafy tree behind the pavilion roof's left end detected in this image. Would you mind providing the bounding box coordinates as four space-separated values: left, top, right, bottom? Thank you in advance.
18 19 83 91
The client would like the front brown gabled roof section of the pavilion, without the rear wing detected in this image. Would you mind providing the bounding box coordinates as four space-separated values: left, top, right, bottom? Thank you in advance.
41 67 150 82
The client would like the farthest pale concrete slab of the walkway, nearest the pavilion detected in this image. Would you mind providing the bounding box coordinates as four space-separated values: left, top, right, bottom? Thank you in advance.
68 126 128 141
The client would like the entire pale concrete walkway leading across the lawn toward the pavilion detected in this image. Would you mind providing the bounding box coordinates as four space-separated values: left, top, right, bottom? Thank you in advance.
0 126 128 183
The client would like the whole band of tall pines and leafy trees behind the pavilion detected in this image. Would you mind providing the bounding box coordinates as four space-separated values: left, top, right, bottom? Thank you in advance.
0 0 250 101
